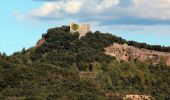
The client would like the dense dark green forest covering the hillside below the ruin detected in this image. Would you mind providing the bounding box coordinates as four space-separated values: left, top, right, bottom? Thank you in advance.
0 26 170 100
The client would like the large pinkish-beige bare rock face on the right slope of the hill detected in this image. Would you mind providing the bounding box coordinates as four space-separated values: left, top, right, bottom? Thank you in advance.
105 43 170 66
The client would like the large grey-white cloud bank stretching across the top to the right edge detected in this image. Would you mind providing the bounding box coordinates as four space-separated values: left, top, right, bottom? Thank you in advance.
17 0 170 25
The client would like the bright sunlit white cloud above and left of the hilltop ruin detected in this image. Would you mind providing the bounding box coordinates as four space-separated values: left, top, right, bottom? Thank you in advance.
25 0 83 18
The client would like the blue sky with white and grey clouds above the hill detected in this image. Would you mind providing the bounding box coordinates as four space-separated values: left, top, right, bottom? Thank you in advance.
0 0 170 55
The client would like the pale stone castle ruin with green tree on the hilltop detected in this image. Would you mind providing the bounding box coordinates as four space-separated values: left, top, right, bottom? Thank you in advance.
70 23 90 38
